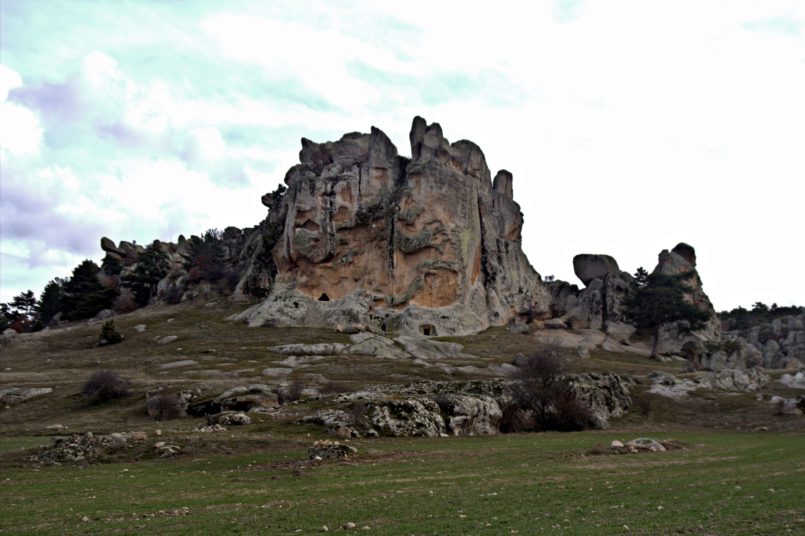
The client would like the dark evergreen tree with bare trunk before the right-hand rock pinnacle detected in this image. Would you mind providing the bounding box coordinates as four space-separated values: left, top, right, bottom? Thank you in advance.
624 274 709 358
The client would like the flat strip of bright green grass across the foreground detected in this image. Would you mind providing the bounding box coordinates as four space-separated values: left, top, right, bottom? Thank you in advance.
0 432 805 535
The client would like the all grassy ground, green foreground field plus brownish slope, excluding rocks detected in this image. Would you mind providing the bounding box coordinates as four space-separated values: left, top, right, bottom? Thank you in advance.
0 303 805 535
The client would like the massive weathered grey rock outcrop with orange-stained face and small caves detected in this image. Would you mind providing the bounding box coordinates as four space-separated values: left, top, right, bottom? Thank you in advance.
237 117 551 335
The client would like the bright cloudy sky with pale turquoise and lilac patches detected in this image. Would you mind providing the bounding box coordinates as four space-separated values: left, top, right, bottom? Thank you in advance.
0 0 805 310
